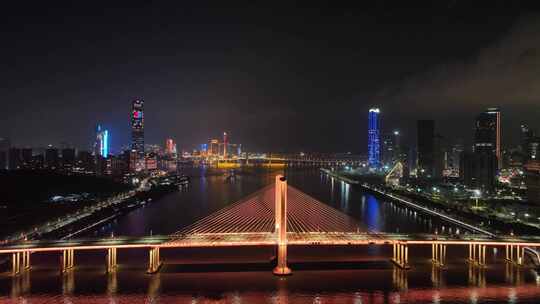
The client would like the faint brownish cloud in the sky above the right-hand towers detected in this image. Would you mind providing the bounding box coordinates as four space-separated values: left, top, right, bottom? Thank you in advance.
378 15 540 143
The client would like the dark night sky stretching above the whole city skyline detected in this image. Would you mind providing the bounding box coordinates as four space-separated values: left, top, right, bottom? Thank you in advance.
0 1 540 152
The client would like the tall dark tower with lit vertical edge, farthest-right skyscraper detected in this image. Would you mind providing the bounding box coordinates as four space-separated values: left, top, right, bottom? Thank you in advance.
474 108 502 169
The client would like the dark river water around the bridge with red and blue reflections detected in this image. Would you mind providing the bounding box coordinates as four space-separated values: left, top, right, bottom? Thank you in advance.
0 170 540 304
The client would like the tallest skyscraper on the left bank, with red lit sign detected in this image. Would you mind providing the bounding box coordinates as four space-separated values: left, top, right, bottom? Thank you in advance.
131 99 145 171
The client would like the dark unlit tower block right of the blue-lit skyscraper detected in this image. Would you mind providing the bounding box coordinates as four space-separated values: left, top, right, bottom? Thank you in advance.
416 120 435 177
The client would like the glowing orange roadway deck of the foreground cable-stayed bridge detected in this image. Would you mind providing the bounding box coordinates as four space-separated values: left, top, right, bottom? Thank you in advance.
0 232 540 253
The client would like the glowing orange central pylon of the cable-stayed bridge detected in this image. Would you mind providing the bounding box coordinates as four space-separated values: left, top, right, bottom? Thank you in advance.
273 175 291 275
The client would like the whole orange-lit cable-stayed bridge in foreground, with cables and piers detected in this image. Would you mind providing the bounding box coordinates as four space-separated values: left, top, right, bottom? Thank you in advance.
0 176 540 275
